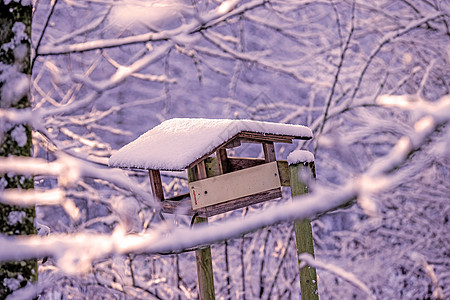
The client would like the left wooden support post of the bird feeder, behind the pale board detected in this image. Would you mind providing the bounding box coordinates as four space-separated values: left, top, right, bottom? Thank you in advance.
188 160 215 300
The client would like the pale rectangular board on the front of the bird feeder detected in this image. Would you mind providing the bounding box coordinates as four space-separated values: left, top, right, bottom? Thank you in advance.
189 161 281 210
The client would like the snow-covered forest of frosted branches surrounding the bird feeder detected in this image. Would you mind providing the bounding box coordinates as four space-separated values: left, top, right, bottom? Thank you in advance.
0 0 450 299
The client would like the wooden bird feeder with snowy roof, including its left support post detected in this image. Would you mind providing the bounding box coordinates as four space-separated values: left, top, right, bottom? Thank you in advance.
109 118 320 299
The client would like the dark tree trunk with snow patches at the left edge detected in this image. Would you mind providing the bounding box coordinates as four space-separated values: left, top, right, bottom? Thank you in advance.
0 1 37 299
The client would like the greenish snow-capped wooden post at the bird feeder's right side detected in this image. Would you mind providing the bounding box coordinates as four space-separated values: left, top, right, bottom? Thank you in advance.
289 162 319 300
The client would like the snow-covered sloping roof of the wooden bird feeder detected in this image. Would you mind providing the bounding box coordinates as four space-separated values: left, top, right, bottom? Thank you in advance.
109 118 312 170
